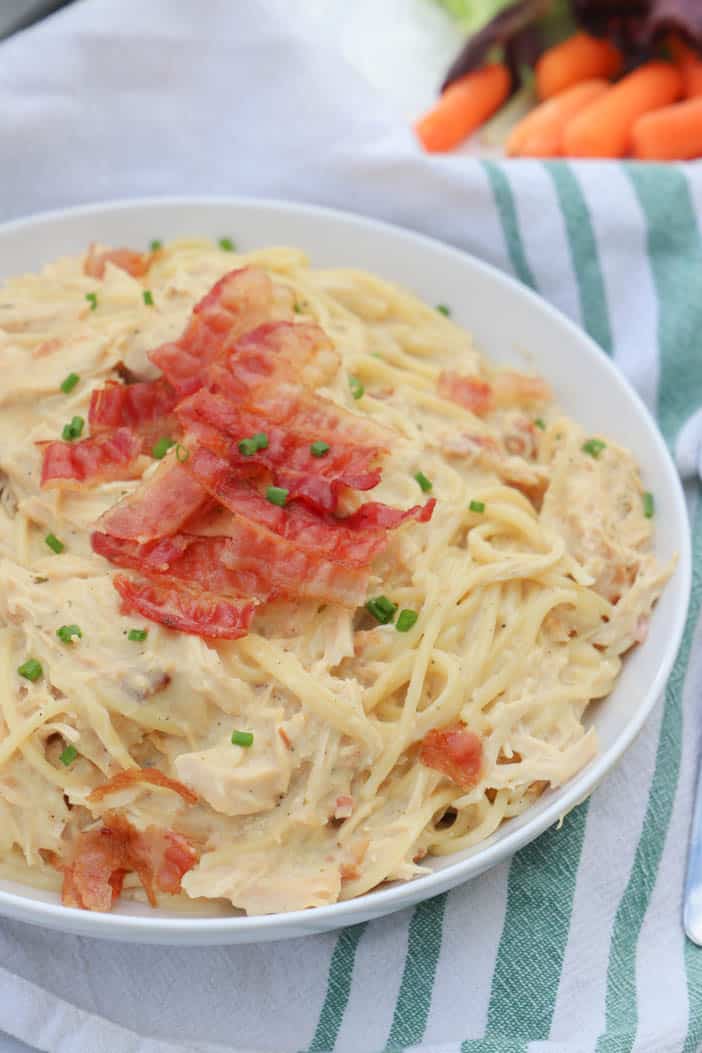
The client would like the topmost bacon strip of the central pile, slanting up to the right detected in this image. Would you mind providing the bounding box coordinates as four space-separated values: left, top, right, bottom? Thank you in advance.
148 267 273 396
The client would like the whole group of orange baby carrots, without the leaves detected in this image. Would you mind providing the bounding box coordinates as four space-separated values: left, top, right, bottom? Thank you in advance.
415 29 702 161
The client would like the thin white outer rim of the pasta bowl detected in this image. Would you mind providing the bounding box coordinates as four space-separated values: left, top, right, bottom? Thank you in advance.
0 194 693 946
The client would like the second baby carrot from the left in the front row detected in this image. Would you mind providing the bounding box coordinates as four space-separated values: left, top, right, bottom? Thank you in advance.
505 80 609 157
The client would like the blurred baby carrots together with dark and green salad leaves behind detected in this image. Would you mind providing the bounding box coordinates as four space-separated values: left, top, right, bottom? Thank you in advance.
416 0 702 160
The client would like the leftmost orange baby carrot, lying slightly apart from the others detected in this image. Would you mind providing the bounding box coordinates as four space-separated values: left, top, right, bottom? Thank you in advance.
415 62 512 154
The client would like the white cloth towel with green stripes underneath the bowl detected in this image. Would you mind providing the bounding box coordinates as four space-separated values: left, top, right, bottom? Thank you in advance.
0 0 702 1053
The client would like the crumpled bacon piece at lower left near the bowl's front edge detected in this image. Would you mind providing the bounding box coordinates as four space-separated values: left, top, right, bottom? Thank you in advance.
58 812 198 911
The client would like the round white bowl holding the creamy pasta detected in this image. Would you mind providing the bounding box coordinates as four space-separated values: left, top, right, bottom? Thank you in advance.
0 198 691 945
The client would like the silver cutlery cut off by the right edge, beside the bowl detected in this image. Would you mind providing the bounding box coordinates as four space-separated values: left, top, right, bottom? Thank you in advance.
676 410 702 946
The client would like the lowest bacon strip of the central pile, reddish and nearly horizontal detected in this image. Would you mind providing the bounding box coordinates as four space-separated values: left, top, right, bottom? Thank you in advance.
113 574 257 640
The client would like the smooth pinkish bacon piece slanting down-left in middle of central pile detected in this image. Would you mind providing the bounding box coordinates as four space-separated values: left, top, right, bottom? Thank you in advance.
98 458 207 542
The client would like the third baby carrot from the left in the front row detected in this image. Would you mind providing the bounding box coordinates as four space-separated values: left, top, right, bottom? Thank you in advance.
563 61 682 157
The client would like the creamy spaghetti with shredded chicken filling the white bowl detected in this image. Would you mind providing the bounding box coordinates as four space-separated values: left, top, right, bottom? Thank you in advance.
0 241 669 914
